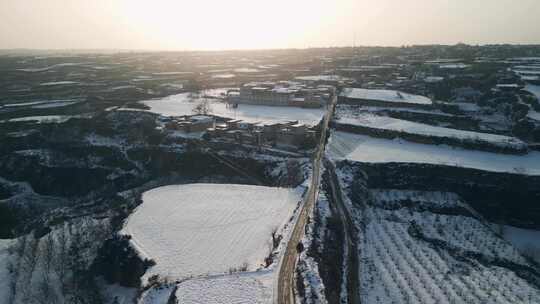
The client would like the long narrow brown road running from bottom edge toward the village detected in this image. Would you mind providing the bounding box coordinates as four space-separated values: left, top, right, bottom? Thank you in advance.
275 96 337 304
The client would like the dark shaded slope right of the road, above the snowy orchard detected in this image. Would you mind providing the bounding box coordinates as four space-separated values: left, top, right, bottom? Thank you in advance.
342 161 540 229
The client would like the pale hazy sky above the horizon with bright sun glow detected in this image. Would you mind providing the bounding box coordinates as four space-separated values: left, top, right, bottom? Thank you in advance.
0 0 540 50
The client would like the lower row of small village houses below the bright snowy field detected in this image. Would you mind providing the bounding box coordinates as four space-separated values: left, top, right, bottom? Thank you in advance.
165 115 317 149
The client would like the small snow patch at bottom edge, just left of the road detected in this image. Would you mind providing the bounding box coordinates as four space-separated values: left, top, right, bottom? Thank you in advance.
176 271 273 304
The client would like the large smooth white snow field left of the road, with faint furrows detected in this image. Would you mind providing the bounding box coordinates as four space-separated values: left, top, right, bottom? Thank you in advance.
122 184 301 279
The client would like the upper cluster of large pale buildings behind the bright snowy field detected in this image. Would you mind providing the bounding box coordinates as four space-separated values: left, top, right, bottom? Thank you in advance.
227 81 335 108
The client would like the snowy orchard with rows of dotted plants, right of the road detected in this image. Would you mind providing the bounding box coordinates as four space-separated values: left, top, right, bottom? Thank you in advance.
338 167 540 304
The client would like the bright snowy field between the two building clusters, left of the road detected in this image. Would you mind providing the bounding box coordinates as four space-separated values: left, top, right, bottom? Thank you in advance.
142 93 325 125
